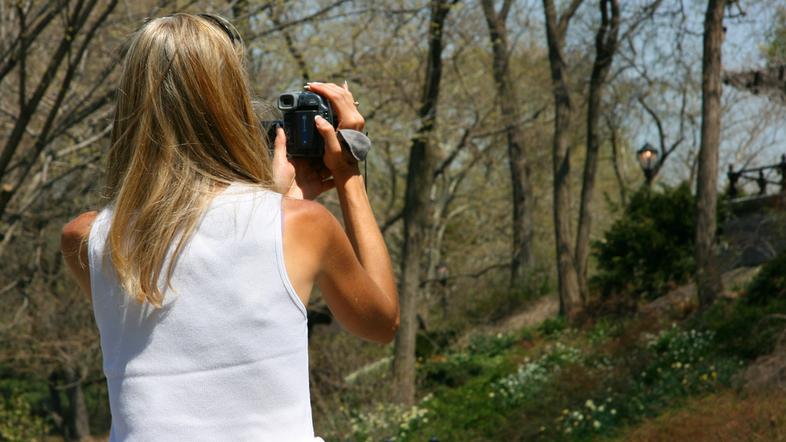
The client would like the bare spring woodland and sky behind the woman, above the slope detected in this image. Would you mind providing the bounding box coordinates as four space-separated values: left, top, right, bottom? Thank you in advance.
0 0 786 439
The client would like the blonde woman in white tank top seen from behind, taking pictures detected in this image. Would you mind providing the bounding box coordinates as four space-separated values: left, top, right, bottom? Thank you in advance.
62 13 399 441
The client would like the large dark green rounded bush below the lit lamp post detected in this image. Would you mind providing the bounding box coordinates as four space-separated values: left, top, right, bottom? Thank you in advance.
591 184 696 299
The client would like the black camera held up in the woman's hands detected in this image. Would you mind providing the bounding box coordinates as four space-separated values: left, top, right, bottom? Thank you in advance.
262 91 338 157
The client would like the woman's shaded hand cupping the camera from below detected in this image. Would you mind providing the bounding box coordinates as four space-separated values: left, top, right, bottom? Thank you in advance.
272 127 335 200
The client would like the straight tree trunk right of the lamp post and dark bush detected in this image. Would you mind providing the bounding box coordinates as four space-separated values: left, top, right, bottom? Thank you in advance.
696 0 725 308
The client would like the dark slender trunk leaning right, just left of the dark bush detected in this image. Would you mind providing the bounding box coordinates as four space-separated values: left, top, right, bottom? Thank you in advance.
576 0 620 302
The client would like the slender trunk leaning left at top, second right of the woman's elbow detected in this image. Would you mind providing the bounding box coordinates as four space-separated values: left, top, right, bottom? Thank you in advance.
481 0 534 287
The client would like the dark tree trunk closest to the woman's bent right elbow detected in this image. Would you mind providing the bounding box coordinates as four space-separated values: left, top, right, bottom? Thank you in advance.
393 0 455 405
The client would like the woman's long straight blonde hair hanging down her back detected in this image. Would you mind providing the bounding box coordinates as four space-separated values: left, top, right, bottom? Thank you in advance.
106 13 273 307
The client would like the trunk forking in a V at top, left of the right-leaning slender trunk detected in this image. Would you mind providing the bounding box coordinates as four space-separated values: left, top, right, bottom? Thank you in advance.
543 0 584 320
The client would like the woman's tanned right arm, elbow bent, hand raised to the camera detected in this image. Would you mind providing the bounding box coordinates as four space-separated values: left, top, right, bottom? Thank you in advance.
274 83 399 343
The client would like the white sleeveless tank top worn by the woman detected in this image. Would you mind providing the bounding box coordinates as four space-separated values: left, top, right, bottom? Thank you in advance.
88 183 322 442
